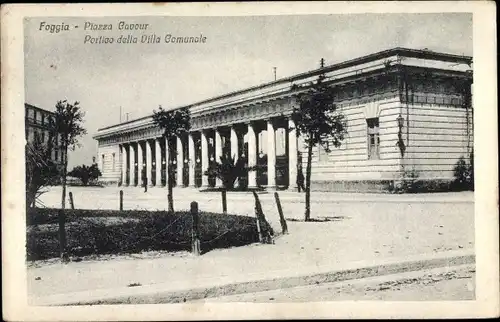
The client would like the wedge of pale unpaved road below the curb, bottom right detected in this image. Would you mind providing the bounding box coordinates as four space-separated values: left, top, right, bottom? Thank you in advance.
195 265 475 303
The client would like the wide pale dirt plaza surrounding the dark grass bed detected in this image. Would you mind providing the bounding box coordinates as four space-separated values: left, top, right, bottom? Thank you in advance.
28 187 474 304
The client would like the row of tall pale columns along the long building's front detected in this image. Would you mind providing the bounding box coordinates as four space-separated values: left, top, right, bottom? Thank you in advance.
120 117 298 189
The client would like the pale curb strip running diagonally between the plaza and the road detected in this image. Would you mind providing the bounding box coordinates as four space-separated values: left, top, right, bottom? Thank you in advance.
30 249 475 306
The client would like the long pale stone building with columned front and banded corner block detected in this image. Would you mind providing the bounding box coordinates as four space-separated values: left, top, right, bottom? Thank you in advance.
94 48 473 191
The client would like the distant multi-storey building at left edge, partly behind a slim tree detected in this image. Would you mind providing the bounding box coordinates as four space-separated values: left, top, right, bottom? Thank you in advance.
24 103 63 163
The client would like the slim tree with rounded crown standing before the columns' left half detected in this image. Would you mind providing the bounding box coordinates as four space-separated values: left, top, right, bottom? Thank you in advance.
153 106 191 212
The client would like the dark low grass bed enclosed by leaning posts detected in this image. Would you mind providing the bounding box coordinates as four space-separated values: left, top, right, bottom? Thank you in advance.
27 208 273 260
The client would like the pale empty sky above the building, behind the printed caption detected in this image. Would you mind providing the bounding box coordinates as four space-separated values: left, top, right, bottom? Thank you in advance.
24 13 473 169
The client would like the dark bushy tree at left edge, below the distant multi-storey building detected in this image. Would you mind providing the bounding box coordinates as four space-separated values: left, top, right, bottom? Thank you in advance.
25 133 60 207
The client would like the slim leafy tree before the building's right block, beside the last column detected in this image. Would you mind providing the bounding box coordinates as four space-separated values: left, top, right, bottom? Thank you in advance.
292 71 347 221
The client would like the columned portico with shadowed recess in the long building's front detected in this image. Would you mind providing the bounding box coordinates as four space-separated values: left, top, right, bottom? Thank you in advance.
99 112 298 189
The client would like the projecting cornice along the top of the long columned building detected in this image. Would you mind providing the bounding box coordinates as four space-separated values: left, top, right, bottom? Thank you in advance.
94 48 472 139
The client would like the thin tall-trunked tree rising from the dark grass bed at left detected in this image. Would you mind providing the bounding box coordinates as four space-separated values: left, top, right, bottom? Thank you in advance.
49 100 87 260
